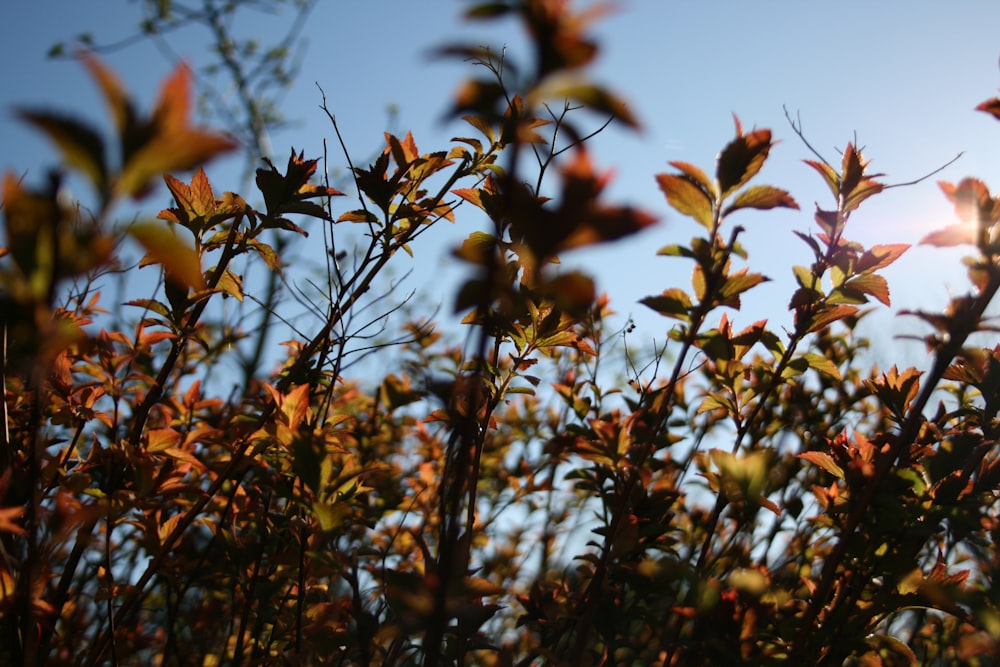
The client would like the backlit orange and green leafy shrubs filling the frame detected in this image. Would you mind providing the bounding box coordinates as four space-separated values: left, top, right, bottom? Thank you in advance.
0 0 1000 665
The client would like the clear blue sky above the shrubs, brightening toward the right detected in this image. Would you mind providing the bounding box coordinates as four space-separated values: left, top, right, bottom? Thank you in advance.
0 0 1000 363
